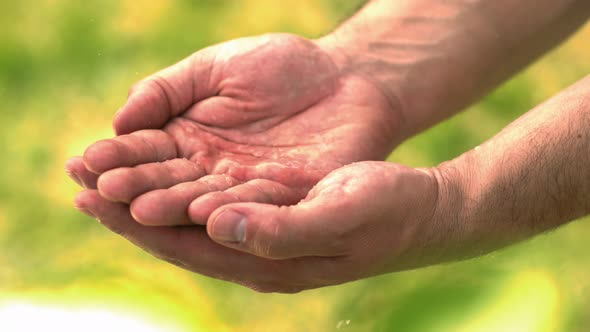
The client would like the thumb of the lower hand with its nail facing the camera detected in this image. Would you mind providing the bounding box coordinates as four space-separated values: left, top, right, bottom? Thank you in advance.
207 199 351 259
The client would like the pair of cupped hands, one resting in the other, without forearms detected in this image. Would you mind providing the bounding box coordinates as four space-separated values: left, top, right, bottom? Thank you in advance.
66 34 440 292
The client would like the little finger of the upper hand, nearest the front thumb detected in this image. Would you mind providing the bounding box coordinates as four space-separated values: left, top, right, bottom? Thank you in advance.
188 179 303 225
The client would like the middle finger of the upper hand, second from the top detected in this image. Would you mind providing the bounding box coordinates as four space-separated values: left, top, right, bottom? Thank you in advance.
98 159 206 203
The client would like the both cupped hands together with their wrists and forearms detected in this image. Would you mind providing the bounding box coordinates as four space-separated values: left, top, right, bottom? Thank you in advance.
66 0 590 292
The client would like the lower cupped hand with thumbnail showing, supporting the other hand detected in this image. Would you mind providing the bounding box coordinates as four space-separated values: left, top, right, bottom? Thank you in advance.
78 162 448 292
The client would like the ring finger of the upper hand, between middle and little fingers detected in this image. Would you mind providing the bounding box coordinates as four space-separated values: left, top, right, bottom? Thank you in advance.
131 175 240 226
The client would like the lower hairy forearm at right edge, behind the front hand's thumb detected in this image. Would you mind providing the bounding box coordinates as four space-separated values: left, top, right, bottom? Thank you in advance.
437 76 590 255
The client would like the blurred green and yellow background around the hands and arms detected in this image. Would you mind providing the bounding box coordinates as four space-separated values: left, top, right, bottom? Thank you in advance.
0 0 590 332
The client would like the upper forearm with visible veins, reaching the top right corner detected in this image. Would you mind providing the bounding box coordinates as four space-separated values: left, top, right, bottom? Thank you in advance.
320 0 590 139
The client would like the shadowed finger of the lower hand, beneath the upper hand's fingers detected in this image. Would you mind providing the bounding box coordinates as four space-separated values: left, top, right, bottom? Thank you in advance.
76 190 313 290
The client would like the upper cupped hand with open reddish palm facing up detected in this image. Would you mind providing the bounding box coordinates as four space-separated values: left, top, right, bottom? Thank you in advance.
66 34 400 225
